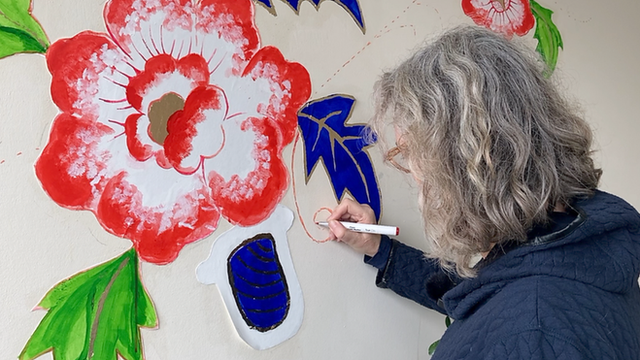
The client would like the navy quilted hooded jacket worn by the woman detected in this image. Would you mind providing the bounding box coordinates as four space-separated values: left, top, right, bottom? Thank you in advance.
366 192 640 360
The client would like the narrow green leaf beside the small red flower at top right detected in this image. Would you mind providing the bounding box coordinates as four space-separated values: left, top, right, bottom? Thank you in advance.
530 0 563 76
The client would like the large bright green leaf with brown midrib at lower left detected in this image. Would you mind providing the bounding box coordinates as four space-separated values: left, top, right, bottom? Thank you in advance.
19 249 157 360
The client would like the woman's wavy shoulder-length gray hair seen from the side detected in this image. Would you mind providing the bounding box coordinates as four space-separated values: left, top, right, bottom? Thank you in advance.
370 26 602 277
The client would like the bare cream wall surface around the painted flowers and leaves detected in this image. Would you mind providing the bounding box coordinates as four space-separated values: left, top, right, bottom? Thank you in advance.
0 0 640 360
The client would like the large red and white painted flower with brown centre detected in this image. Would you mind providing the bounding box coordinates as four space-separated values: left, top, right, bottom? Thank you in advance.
35 0 311 264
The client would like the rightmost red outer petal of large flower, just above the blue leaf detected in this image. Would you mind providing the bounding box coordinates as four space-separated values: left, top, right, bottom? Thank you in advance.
243 46 311 146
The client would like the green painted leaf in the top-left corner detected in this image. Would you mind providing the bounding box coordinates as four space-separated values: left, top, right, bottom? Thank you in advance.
0 0 49 58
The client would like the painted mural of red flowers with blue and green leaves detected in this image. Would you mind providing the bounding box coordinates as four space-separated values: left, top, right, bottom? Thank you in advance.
0 0 563 360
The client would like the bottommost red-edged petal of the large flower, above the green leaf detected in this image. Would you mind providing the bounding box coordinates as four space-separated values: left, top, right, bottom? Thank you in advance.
96 172 220 264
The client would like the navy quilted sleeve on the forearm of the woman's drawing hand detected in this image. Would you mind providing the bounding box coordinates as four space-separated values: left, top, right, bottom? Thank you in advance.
376 240 455 315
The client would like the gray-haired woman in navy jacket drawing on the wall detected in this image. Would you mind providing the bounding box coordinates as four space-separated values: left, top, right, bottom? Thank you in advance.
329 27 640 360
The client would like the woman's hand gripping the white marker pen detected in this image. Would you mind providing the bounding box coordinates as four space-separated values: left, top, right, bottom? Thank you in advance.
327 199 380 256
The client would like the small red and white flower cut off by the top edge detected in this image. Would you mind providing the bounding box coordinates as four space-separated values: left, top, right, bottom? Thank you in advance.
462 0 535 38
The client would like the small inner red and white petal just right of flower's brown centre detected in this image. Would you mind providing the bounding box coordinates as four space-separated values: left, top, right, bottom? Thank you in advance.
164 85 229 174
